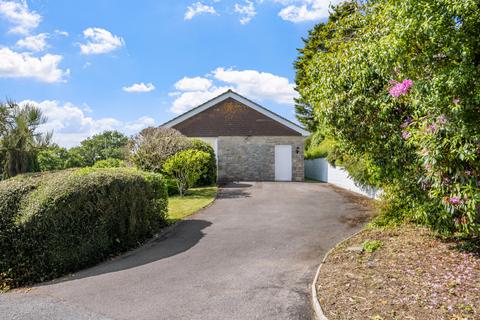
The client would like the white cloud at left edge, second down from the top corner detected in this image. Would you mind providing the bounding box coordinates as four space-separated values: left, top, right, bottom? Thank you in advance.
0 48 70 82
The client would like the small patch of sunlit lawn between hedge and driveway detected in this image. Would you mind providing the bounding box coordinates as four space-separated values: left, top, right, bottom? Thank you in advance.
168 187 217 222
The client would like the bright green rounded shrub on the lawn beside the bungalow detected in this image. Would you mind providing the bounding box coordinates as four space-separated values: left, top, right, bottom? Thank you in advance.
163 149 211 196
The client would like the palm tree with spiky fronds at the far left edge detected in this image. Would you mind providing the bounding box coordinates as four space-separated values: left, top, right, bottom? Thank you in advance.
0 101 51 178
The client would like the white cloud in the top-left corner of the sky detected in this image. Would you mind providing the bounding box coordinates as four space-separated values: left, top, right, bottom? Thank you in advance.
0 0 42 34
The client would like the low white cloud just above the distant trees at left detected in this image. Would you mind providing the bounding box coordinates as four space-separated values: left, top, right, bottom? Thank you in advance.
20 100 155 147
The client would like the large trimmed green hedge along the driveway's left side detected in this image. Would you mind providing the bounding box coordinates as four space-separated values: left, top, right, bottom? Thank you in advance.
0 168 168 289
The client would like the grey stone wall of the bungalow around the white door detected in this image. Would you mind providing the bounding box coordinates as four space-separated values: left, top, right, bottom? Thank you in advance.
218 136 304 182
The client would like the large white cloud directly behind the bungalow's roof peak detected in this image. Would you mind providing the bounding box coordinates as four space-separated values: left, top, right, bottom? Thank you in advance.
169 68 297 114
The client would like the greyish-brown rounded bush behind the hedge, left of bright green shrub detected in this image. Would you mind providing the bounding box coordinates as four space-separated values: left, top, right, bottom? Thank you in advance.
130 127 191 173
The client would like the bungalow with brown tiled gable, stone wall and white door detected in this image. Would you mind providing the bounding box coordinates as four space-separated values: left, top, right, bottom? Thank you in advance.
162 90 309 182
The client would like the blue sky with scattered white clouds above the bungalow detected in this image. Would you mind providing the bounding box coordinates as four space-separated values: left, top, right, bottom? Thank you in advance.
0 0 339 147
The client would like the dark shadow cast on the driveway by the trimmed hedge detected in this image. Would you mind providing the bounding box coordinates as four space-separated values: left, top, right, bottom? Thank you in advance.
38 219 212 286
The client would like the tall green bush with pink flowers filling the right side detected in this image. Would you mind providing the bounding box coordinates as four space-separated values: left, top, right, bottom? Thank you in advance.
298 0 480 236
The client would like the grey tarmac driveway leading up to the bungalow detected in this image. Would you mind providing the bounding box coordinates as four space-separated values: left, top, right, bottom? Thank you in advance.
0 182 368 320
